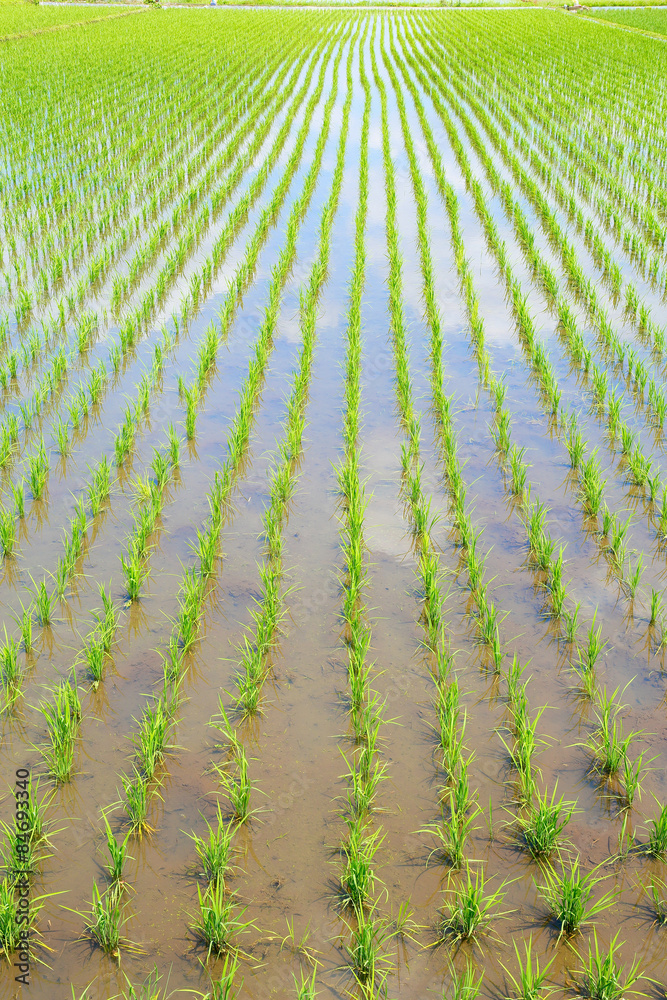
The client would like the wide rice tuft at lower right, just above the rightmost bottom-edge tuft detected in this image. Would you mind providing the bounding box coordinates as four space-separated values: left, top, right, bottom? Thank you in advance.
537 858 619 940
